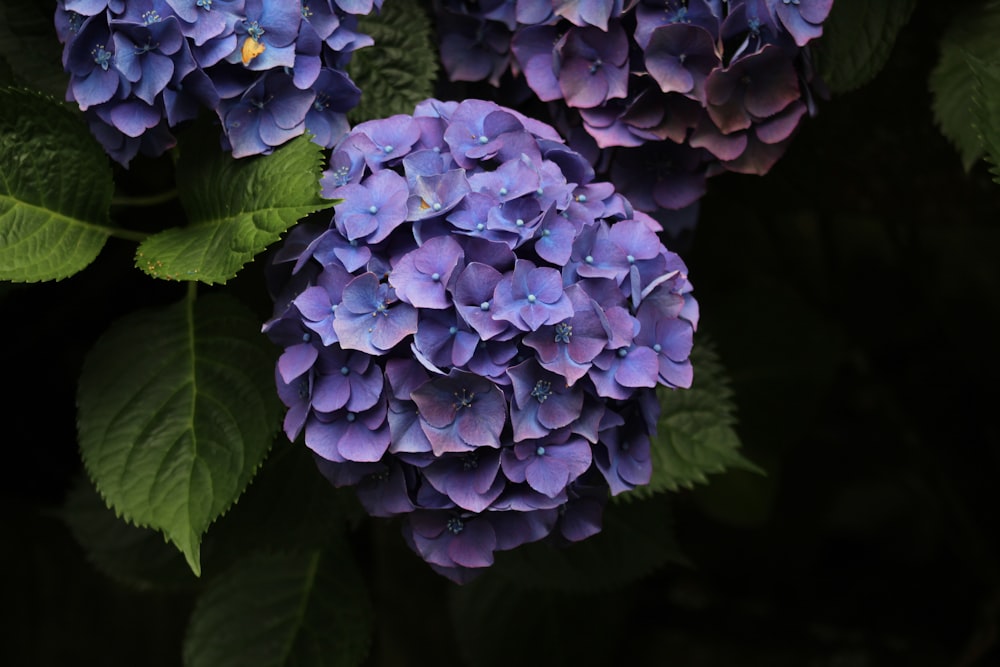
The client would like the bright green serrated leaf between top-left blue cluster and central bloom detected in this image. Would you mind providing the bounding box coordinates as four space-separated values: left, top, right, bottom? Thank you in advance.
136 133 334 284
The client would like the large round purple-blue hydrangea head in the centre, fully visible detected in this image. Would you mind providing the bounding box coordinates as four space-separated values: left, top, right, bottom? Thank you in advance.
264 99 698 581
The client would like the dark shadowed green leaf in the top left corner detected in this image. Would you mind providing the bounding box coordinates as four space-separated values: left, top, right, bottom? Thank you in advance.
0 0 69 99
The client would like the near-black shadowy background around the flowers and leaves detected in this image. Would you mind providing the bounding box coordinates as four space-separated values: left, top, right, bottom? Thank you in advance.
0 3 1000 667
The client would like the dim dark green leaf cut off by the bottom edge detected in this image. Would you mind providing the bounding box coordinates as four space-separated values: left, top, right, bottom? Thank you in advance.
184 547 373 667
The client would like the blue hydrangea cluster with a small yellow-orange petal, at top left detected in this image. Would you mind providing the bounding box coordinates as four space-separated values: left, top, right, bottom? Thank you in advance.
55 0 382 165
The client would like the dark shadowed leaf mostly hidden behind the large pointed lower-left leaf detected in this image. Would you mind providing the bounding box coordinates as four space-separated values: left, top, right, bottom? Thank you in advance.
59 474 197 590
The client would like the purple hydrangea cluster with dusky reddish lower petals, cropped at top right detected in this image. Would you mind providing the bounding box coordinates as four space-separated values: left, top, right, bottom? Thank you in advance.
437 0 833 224
